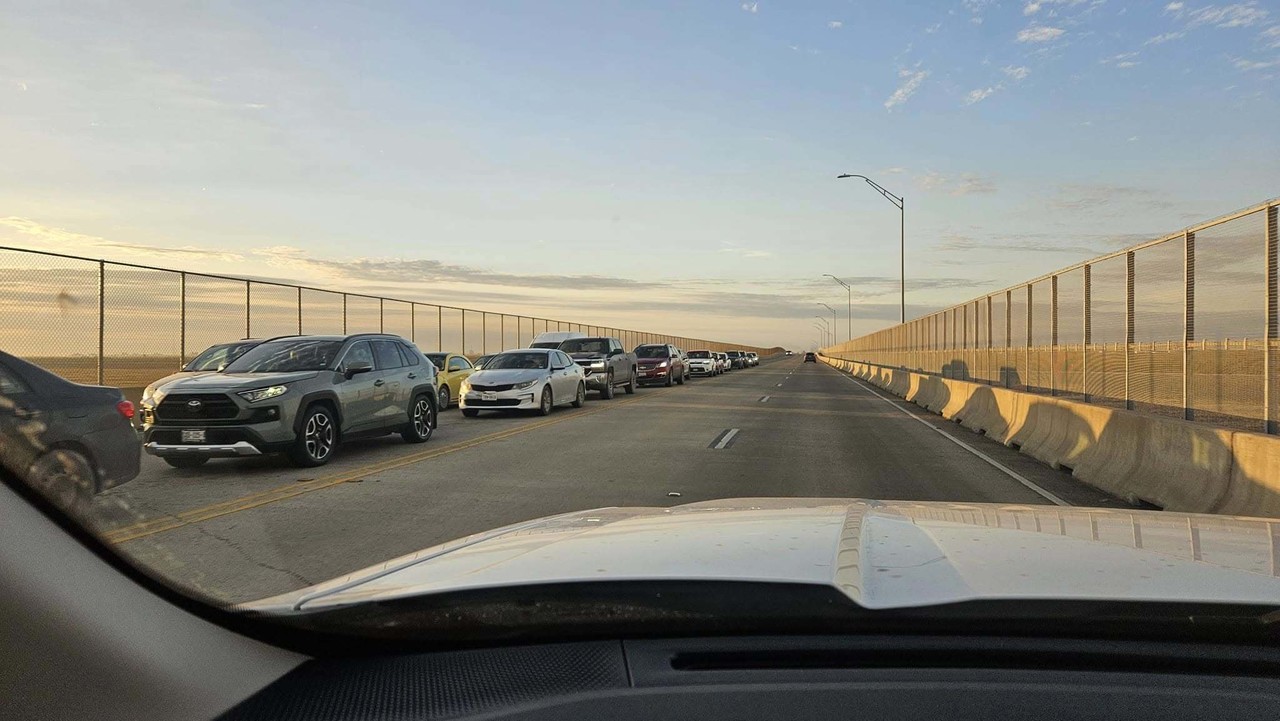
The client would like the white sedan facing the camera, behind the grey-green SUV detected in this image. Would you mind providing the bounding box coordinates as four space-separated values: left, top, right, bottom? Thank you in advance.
458 348 586 417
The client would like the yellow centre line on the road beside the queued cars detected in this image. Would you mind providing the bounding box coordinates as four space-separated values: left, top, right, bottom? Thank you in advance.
102 388 675 544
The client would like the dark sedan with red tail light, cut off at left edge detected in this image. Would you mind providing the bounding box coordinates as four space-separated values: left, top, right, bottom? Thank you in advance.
0 352 142 510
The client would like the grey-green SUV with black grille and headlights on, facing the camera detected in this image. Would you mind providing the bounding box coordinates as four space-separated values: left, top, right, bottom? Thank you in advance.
142 333 436 469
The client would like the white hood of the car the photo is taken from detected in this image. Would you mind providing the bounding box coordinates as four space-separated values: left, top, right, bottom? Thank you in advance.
243 498 1280 612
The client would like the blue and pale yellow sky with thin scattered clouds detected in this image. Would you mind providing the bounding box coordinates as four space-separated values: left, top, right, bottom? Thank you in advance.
0 0 1280 348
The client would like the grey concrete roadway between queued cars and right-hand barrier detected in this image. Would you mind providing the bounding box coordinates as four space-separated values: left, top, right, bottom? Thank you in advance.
99 356 1121 602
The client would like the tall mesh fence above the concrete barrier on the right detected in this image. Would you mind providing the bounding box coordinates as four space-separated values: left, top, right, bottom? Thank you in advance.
823 198 1280 433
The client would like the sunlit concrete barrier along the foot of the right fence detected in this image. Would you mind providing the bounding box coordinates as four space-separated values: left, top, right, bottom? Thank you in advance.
832 353 1254 516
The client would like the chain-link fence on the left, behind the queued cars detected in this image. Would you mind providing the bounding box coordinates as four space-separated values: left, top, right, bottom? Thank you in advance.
0 247 781 388
